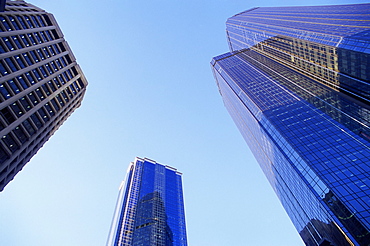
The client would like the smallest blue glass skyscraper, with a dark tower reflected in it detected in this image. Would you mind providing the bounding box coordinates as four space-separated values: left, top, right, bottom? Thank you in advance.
107 158 187 246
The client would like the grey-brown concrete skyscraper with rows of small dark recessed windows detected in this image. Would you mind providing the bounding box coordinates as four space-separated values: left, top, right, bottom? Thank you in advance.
0 1 87 191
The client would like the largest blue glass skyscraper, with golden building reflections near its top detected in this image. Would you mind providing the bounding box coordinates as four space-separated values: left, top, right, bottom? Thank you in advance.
211 4 370 246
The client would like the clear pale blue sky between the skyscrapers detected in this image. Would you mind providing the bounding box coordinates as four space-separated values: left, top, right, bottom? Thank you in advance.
0 0 366 246
